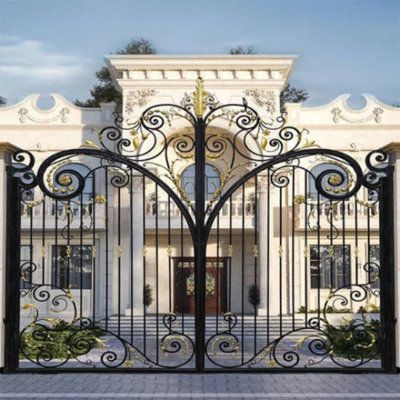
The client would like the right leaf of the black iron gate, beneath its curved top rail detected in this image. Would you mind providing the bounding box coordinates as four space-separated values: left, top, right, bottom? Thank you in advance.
206 154 390 369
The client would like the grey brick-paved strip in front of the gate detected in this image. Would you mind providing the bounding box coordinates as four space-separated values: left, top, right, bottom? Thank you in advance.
0 373 400 400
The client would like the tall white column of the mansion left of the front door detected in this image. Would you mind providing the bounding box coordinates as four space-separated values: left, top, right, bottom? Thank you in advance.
121 175 146 315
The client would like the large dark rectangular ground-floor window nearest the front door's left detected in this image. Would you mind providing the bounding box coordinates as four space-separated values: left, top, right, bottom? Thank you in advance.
51 245 92 289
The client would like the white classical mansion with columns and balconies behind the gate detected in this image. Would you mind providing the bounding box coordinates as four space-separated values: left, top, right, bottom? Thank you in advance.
0 55 400 365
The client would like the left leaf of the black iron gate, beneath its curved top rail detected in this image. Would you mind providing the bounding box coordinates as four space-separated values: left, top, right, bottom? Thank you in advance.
12 156 195 369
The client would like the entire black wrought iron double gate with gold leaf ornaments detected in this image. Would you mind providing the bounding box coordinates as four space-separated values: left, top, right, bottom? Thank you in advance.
5 78 395 372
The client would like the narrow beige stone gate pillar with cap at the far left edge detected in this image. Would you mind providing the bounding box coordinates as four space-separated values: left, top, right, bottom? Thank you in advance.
0 142 18 369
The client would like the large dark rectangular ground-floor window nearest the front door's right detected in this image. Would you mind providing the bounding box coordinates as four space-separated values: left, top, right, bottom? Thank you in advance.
310 245 350 289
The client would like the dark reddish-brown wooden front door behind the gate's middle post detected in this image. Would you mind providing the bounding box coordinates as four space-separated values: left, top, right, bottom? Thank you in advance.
174 257 227 314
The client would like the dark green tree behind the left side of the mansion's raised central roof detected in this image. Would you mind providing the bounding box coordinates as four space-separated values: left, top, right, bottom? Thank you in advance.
75 38 156 108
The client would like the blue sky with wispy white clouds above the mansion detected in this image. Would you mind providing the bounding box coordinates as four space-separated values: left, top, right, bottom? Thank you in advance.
0 0 400 108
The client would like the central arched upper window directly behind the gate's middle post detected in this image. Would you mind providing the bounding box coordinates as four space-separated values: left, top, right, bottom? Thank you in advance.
180 164 221 201
